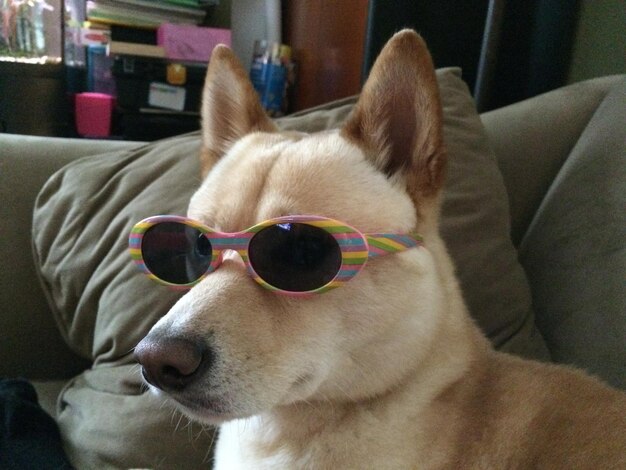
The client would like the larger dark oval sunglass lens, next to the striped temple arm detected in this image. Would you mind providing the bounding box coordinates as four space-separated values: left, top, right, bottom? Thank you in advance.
248 223 341 292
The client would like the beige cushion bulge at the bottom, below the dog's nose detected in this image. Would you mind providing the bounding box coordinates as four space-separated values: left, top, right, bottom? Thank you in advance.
57 365 215 470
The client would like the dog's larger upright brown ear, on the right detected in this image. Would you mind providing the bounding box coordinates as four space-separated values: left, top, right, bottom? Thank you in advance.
342 30 446 199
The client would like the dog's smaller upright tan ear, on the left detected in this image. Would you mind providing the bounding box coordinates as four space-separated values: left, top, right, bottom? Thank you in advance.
201 45 276 176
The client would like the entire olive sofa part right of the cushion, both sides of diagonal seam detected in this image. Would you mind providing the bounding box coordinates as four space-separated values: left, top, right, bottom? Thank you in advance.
482 75 626 389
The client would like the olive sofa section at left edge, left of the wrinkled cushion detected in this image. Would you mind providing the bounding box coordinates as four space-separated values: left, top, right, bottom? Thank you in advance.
0 134 139 379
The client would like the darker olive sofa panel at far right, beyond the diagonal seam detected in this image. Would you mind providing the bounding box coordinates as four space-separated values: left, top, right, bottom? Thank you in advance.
520 78 626 389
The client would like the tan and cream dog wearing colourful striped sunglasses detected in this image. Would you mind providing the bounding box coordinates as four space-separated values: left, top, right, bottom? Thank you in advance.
135 30 626 470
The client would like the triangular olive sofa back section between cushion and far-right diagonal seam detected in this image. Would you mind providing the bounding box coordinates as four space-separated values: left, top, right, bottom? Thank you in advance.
481 75 624 247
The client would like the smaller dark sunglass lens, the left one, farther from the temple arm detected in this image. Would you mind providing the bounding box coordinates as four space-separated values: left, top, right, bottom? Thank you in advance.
141 222 212 284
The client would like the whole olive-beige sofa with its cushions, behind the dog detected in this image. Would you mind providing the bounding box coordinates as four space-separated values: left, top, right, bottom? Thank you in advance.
0 68 626 469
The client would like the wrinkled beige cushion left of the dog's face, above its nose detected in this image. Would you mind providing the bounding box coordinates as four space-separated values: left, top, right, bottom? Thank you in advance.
33 136 200 365
